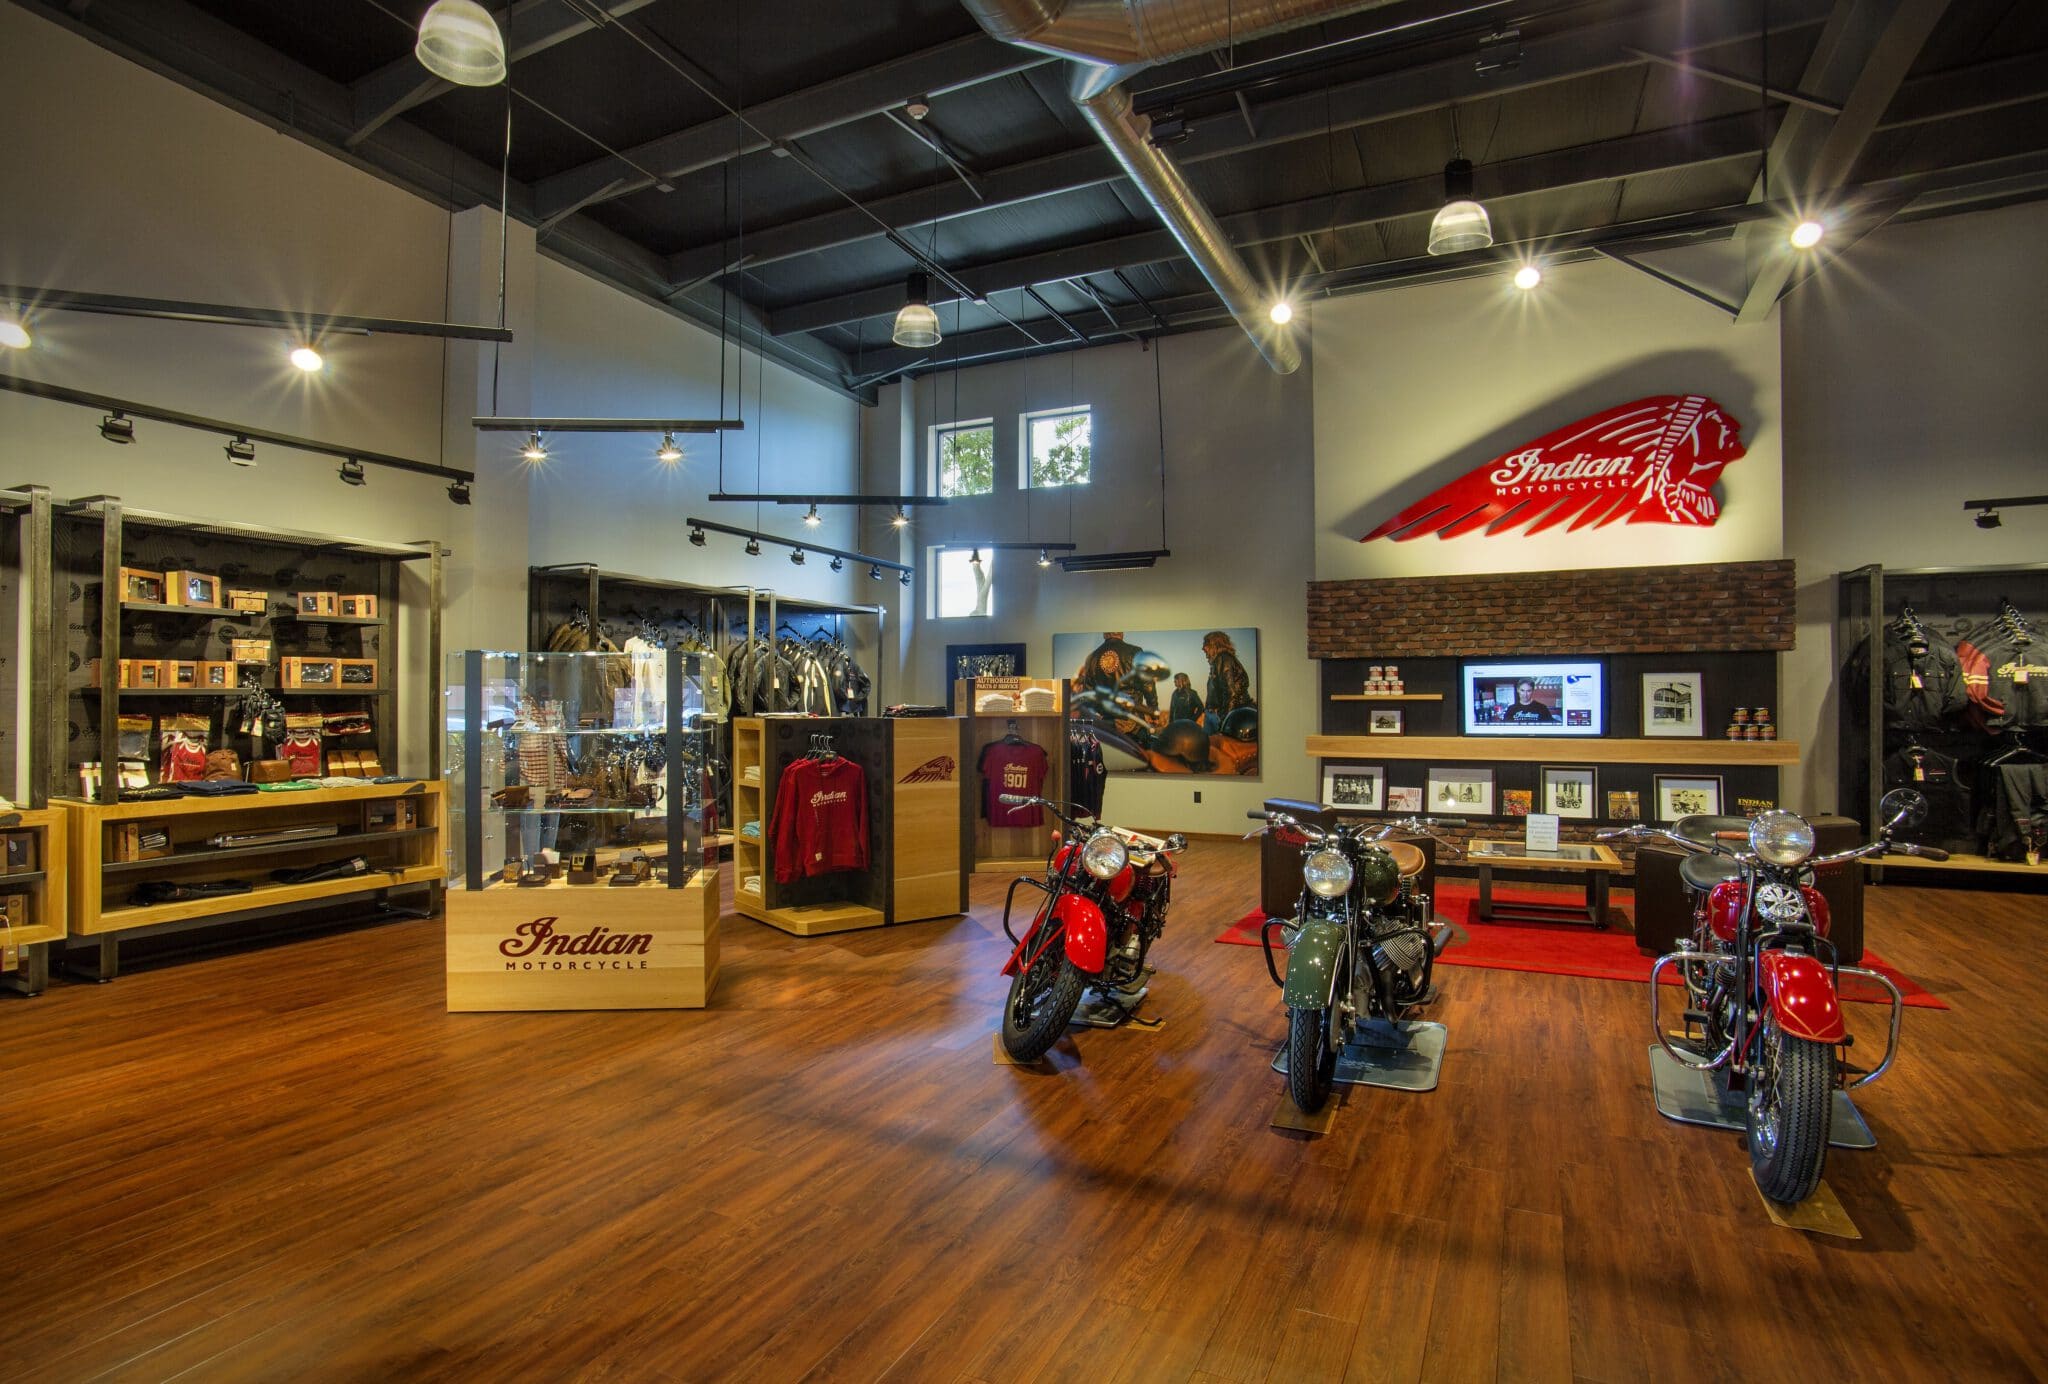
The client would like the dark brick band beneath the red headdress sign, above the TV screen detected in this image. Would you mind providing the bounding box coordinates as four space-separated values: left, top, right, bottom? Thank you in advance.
1309 557 1796 659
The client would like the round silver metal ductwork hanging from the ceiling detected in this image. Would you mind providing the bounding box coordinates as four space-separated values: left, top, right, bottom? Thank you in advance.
961 0 1393 375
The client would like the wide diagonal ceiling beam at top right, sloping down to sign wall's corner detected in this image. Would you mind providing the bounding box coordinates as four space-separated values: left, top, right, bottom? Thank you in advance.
1735 0 1948 321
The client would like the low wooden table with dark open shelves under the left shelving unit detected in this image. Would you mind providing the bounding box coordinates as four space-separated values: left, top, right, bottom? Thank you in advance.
57 780 446 981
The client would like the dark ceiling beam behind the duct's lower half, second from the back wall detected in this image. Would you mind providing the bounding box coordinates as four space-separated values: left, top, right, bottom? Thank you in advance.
768 115 1757 334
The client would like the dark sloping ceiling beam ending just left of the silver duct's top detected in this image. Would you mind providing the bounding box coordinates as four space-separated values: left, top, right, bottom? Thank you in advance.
535 33 1053 219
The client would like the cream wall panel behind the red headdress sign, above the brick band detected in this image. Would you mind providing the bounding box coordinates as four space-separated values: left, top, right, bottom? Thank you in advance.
1313 260 1782 579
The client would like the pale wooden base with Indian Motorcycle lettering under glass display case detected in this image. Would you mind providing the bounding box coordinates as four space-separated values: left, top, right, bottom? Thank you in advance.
446 866 719 1011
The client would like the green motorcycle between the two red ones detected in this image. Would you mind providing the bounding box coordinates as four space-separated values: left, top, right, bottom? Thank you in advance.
1247 803 1464 1114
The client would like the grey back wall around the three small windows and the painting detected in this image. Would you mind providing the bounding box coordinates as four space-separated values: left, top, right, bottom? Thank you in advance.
864 328 1315 833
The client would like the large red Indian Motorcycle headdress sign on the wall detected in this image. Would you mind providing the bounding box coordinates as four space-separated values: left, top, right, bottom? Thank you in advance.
1360 393 1749 543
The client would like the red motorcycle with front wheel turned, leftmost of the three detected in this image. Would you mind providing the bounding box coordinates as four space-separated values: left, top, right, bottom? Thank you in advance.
999 792 1188 1063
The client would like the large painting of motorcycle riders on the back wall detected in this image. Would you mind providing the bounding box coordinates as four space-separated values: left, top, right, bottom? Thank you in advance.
1053 629 1260 776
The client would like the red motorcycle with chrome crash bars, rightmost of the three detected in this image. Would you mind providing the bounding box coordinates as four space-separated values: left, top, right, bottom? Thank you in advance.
1599 788 1948 1202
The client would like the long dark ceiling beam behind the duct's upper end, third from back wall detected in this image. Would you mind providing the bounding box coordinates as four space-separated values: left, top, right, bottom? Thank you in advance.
663 0 1829 283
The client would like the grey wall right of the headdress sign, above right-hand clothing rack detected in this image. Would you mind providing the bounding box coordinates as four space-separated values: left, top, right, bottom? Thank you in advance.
1780 203 2048 815
